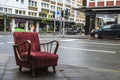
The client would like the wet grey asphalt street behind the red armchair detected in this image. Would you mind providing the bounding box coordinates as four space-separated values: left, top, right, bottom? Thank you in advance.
0 35 120 70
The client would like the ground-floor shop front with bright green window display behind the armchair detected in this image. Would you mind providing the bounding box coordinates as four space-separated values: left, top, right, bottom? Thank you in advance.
0 13 41 32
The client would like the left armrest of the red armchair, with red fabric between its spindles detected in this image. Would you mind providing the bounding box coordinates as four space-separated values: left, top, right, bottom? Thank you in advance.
13 40 31 61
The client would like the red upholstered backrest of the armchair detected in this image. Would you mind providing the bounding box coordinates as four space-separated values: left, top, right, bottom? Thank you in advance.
13 32 40 52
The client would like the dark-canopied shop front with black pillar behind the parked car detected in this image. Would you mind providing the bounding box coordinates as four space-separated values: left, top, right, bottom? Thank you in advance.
76 6 120 35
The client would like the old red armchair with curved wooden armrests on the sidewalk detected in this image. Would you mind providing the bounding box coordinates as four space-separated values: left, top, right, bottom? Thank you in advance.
13 32 59 76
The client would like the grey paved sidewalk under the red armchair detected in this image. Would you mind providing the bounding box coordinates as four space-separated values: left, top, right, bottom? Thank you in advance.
0 55 120 80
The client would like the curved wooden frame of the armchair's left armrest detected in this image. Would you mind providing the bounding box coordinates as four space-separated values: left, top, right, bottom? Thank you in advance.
13 40 31 61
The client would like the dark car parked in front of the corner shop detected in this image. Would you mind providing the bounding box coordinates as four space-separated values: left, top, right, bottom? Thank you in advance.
90 24 120 38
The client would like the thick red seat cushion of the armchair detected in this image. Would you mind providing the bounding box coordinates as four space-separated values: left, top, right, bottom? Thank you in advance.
22 52 58 68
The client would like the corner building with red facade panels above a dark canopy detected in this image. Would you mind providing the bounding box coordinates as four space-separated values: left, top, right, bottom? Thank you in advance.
77 0 120 35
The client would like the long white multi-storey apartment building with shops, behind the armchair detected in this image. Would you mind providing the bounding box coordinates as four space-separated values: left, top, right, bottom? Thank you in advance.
0 0 85 32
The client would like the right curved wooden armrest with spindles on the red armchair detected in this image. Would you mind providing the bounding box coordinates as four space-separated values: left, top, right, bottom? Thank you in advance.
40 40 59 54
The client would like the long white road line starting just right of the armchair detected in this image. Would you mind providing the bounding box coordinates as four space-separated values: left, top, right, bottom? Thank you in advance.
59 47 116 54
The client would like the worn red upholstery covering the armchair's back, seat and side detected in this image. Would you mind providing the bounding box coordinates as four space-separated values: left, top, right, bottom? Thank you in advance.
13 32 58 75
